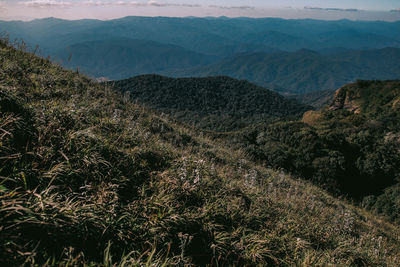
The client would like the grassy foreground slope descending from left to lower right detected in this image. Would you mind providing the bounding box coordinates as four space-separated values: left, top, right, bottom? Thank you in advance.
0 38 400 266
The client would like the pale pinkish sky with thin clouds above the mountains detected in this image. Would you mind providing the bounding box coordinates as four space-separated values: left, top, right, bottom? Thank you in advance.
0 0 400 21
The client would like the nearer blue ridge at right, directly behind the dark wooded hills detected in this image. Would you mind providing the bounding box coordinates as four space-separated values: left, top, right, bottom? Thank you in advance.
170 48 400 94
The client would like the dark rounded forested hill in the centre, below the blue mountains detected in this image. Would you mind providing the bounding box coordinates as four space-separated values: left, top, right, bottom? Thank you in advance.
108 75 310 131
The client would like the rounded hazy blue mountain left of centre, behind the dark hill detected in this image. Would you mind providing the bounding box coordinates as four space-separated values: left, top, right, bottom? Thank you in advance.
55 39 216 80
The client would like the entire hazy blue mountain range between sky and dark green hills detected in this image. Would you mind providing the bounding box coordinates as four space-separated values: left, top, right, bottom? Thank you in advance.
0 17 400 94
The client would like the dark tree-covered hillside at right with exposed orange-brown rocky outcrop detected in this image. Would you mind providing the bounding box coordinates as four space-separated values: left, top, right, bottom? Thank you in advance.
224 81 400 222
